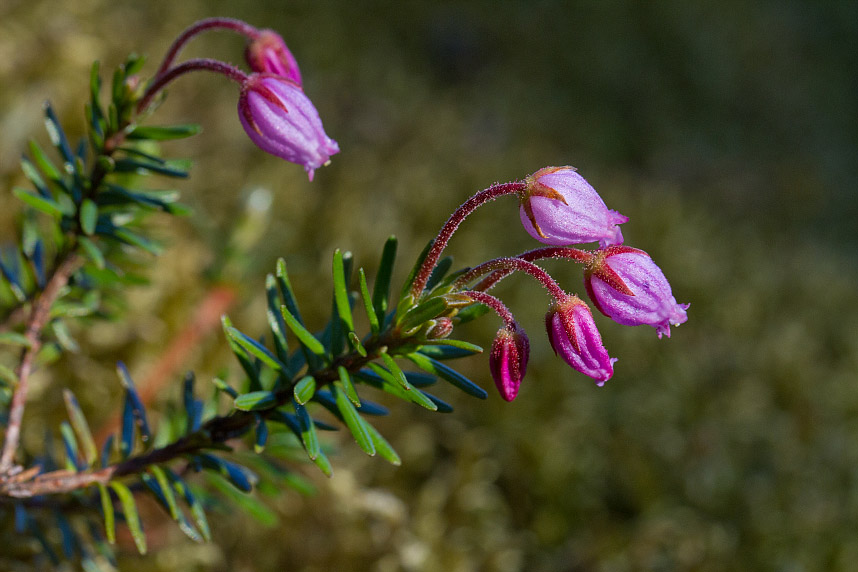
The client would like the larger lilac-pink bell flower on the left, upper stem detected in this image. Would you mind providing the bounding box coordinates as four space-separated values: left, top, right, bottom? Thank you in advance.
238 74 340 181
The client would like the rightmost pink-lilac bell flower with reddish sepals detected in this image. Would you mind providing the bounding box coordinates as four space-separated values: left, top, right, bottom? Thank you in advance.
584 246 689 338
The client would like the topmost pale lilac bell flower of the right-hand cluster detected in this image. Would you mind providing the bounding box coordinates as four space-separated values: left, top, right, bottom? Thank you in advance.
520 167 629 247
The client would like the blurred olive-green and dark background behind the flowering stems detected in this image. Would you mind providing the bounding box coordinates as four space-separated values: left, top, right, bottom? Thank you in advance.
0 0 858 572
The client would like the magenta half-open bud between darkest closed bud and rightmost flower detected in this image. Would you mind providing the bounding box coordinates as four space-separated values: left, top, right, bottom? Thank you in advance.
545 296 617 387
